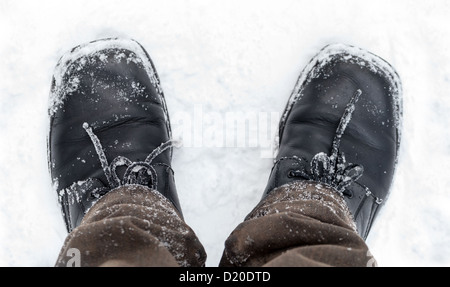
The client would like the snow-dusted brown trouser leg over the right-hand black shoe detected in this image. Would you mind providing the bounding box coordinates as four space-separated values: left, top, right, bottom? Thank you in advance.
220 181 375 266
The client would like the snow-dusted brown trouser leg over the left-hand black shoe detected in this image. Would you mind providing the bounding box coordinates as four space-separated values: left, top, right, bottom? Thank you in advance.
56 185 206 266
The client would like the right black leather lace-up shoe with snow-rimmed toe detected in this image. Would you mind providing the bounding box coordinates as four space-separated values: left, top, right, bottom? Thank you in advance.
263 44 402 239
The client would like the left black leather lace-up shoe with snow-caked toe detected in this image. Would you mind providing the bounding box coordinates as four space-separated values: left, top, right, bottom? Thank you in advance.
48 39 181 232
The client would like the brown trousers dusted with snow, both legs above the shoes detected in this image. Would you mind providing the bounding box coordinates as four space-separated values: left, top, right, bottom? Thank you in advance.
56 182 374 266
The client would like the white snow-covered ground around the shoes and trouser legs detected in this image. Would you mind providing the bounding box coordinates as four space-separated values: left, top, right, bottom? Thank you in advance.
0 0 450 266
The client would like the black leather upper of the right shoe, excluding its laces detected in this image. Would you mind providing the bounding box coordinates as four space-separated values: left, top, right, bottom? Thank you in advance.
263 45 399 238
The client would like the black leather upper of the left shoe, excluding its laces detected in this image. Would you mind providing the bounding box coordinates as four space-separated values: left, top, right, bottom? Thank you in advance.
49 39 181 232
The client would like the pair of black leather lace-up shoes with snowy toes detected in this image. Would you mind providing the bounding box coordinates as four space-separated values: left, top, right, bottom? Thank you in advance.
48 39 402 268
